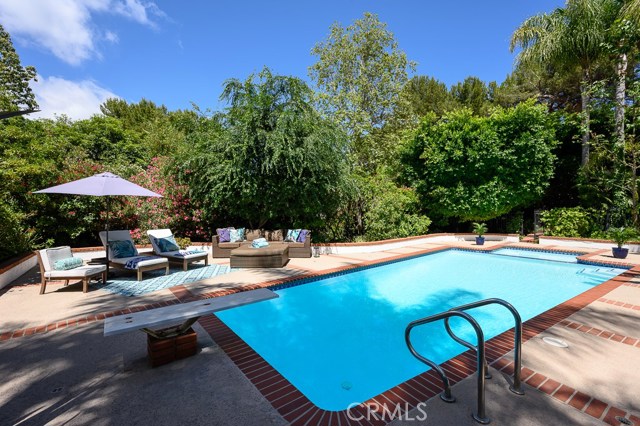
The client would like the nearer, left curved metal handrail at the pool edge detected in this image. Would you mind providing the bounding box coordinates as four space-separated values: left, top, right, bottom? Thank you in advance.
404 310 491 424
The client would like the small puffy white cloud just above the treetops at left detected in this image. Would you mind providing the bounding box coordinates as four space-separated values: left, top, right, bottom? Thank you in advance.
29 76 118 120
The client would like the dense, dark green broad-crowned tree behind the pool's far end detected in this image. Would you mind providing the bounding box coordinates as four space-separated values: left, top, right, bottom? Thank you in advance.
401 101 556 223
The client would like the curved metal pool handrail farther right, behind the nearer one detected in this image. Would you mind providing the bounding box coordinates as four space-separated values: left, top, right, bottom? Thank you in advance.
444 298 524 395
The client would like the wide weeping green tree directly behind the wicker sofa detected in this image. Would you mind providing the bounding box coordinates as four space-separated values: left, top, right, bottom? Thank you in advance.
181 68 348 228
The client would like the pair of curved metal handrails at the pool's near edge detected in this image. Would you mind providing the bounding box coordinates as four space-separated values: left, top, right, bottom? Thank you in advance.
404 298 524 424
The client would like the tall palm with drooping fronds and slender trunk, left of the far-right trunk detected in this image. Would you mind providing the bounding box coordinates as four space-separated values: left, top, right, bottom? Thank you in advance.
511 0 618 167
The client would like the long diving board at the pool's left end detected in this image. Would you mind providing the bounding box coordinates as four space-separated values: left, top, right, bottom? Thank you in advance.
104 288 279 338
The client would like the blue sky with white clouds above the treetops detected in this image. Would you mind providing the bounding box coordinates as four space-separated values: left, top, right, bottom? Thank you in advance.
0 0 564 119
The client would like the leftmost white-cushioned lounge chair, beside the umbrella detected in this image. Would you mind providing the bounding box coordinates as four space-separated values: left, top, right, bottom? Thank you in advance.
36 246 107 294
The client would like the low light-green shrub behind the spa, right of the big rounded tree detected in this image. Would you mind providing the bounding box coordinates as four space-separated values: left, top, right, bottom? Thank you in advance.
541 207 601 237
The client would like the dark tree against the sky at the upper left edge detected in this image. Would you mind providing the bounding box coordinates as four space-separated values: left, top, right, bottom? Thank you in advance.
0 25 38 111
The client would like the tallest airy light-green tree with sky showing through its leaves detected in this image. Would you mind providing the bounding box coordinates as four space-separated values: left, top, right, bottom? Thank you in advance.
309 13 415 170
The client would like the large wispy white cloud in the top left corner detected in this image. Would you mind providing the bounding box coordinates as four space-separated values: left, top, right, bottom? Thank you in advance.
0 0 166 65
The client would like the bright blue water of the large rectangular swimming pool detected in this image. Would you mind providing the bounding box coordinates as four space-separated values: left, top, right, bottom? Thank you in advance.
217 250 623 410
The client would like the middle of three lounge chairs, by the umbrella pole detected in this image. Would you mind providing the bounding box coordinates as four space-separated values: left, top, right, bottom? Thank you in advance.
100 230 169 281
